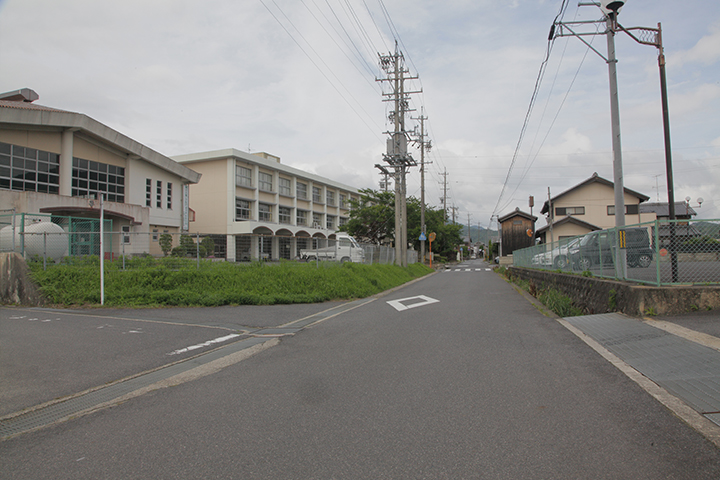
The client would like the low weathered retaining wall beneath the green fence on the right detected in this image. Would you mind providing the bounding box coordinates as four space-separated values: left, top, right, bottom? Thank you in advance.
508 267 720 317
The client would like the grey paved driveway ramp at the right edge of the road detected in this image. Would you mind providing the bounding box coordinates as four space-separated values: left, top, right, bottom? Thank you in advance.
564 313 720 425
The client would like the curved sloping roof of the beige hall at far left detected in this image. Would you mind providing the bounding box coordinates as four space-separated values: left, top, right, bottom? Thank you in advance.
0 89 201 183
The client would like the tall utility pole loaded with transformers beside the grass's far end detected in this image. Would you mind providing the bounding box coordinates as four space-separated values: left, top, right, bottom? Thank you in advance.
376 42 422 267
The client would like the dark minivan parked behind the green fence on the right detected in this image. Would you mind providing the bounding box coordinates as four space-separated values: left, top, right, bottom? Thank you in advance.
568 228 654 270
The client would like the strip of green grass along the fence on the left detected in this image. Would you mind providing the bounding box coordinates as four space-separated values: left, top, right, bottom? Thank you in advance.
29 258 432 307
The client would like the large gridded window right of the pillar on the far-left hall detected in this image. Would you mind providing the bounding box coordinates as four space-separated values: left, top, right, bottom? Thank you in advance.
72 158 125 203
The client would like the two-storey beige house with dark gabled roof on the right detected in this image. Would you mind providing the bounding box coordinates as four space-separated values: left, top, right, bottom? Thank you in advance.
535 173 655 243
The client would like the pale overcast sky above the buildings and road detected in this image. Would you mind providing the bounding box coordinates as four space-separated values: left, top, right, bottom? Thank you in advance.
0 0 720 227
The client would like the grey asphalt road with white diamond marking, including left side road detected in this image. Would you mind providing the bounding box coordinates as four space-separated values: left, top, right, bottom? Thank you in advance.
0 261 720 480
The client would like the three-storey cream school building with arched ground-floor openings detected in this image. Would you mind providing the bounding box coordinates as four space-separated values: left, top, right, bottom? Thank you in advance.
173 148 360 261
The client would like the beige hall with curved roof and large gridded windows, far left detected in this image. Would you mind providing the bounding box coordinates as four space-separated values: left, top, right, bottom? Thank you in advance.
0 88 200 255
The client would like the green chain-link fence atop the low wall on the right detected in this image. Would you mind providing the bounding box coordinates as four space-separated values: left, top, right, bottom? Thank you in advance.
513 220 720 285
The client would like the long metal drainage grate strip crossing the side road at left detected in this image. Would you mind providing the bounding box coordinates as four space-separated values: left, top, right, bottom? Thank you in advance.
0 338 267 438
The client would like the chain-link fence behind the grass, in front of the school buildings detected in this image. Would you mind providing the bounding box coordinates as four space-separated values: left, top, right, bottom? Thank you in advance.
0 214 417 269
